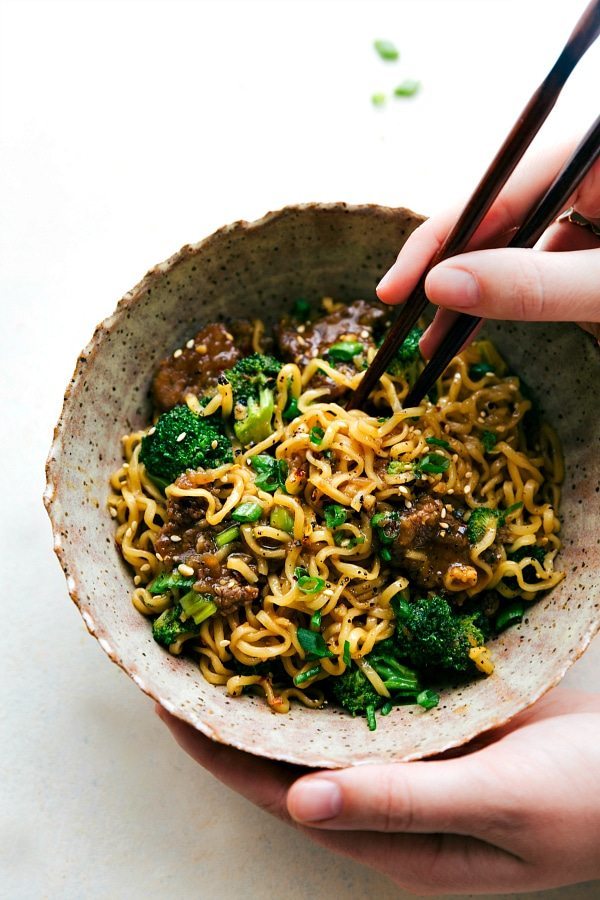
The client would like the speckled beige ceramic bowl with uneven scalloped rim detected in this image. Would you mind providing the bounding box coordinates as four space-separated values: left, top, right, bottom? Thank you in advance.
45 203 600 767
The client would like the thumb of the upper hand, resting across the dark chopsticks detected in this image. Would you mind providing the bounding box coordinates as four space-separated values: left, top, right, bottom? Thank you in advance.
425 248 600 322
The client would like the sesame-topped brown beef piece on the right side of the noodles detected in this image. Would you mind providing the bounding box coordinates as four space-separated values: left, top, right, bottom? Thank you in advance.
390 495 477 590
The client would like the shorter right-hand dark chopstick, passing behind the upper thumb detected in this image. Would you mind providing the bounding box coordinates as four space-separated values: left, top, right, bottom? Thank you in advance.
403 116 600 409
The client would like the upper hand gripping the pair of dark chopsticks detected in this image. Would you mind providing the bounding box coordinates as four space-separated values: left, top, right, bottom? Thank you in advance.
377 146 600 357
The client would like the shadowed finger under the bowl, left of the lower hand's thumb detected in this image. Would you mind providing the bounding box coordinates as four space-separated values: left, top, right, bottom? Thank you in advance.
156 705 304 821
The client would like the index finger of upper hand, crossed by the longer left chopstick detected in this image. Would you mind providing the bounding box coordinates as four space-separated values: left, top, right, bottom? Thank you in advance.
377 142 576 303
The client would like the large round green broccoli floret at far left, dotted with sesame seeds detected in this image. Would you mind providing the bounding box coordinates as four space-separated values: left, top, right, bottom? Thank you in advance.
140 406 233 484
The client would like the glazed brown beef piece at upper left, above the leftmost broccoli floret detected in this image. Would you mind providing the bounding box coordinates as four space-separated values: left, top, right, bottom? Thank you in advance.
152 319 253 412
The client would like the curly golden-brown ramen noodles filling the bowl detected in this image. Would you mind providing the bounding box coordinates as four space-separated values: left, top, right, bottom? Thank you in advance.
108 300 564 724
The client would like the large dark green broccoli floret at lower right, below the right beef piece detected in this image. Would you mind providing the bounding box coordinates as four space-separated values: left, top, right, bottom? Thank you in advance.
392 596 483 672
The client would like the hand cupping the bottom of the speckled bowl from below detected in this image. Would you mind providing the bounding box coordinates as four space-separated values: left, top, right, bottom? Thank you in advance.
157 689 600 894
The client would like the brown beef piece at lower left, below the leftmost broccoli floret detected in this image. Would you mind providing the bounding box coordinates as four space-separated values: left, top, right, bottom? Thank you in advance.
155 475 259 615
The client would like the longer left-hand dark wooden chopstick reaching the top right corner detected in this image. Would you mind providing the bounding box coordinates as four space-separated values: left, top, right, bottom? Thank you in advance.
346 0 600 409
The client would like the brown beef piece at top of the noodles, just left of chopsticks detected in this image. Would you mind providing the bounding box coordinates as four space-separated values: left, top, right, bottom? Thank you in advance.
276 300 388 399
